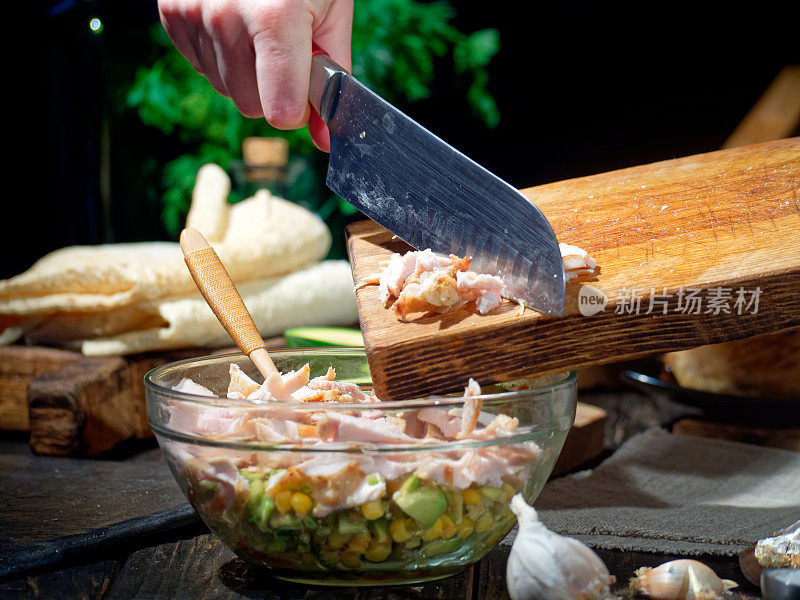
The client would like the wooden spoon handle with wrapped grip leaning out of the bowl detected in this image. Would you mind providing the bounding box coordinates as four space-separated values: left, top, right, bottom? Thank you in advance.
181 228 278 378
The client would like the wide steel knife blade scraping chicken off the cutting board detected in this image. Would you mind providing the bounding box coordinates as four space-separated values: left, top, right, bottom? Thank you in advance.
309 51 564 315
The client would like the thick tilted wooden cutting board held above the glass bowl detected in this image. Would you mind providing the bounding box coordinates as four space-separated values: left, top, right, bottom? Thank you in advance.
347 138 800 400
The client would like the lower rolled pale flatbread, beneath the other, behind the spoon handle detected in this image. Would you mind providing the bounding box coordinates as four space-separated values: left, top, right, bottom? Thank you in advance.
80 260 358 356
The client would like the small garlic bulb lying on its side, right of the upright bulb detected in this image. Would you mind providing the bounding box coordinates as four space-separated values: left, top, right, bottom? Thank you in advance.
631 559 737 600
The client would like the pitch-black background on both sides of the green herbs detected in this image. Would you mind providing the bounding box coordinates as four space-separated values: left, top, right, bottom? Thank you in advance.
0 0 800 278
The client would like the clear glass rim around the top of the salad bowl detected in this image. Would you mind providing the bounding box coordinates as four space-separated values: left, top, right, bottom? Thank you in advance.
144 346 578 411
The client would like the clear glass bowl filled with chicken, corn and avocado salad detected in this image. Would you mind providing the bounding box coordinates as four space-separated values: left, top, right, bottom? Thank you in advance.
145 348 577 585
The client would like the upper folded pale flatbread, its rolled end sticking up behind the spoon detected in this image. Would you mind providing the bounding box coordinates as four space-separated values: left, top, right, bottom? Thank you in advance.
0 165 331 314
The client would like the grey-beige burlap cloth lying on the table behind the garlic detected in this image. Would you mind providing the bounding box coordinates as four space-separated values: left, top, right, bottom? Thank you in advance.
504 429 800 555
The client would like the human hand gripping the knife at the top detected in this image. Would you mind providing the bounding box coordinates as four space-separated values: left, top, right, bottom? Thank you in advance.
158 0 353 152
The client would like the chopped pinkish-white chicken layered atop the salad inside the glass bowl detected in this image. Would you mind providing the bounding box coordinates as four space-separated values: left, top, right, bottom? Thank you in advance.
169 364 538 496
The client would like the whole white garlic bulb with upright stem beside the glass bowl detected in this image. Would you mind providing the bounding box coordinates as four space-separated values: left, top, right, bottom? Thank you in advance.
506 494 617 600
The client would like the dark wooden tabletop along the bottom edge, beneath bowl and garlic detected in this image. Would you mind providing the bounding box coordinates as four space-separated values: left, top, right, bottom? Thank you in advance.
0 534 760 600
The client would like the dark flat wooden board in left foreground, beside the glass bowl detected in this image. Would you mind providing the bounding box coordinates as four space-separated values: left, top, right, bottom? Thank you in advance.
0 455 200 580
